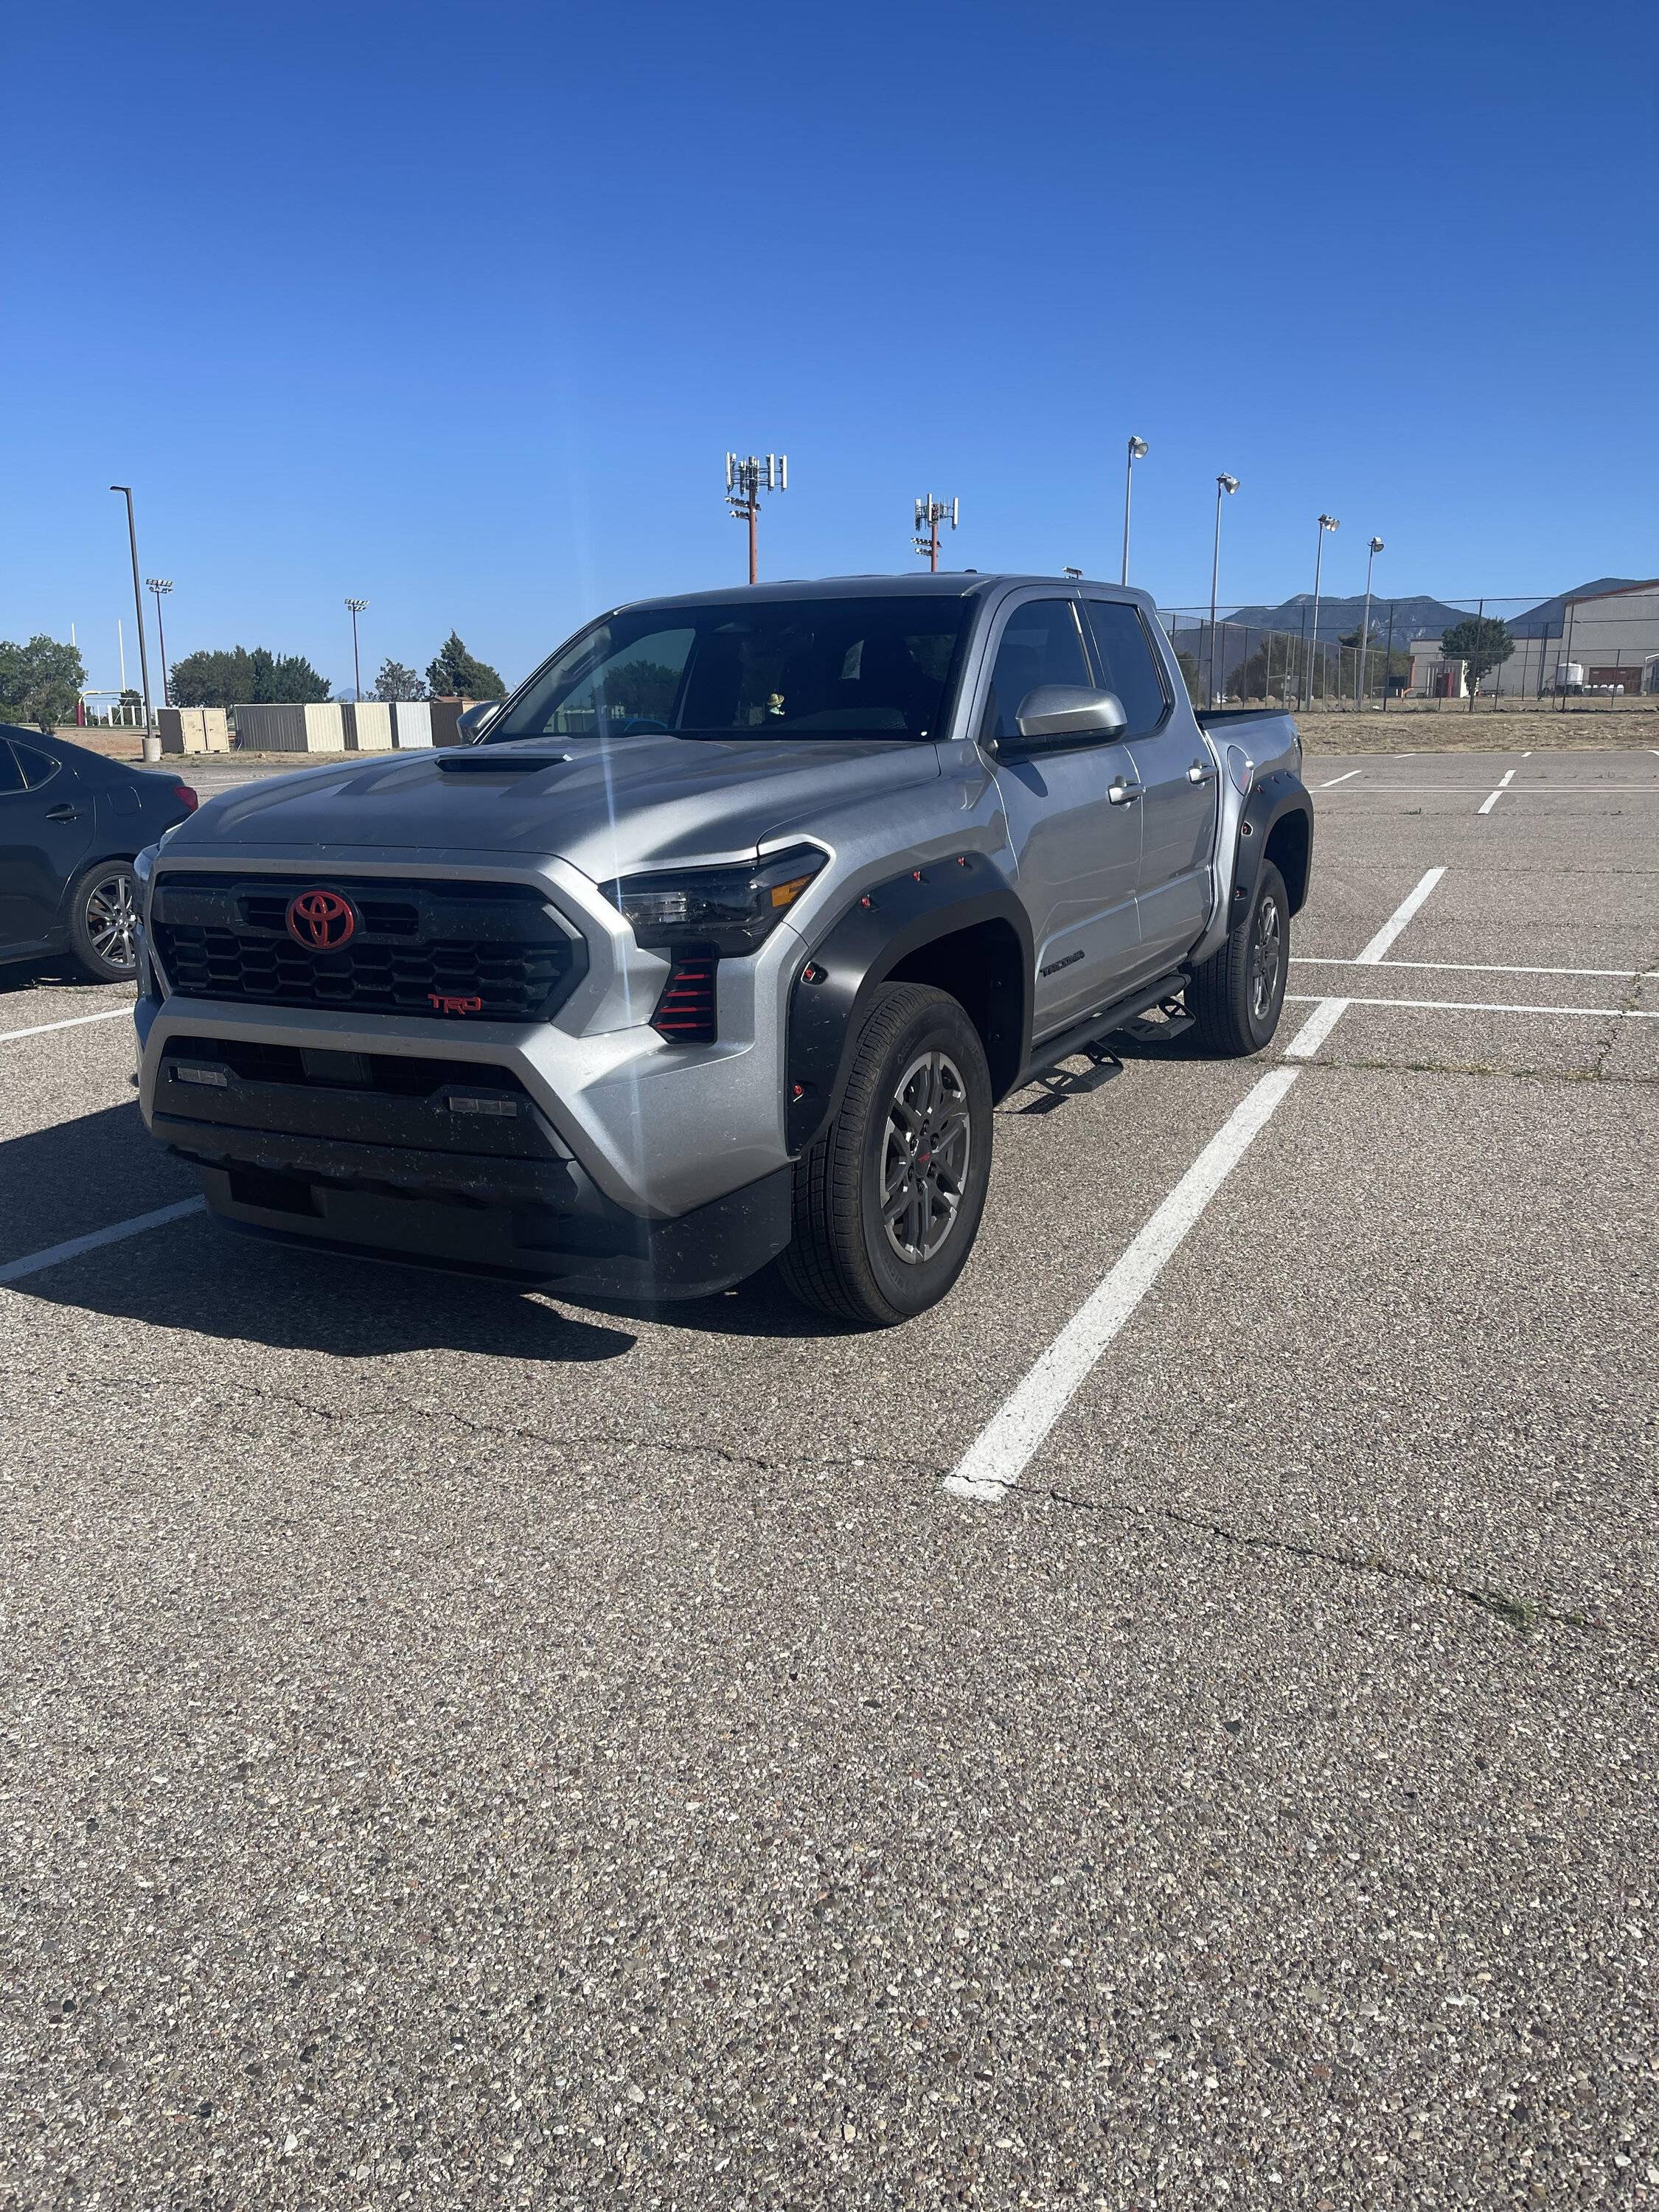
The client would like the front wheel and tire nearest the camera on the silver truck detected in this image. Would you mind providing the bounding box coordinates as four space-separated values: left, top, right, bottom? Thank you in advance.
779 982 993 1329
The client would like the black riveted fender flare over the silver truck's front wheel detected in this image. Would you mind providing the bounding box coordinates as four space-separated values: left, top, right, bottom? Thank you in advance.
785 852 1033 1152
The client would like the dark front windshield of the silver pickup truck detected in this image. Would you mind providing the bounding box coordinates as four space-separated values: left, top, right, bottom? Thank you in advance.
487 595 973 745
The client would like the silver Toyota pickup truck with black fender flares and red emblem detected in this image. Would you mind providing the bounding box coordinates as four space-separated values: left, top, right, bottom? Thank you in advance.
137 573 1312 1327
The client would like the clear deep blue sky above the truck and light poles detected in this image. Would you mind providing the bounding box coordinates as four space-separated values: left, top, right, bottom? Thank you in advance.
0 0 1659 686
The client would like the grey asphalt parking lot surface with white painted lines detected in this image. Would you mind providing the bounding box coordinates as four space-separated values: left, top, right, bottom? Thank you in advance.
0 750 1659 2212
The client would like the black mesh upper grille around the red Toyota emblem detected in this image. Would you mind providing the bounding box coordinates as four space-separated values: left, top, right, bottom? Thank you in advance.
150 872 586 1022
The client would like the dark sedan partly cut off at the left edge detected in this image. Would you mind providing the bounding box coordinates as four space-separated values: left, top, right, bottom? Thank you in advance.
0 723 197 982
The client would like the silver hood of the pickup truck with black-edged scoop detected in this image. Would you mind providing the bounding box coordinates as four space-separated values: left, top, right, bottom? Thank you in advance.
184 734 940 883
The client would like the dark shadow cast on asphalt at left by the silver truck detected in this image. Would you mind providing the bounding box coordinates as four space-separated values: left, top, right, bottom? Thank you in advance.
0 1104 637 1363
